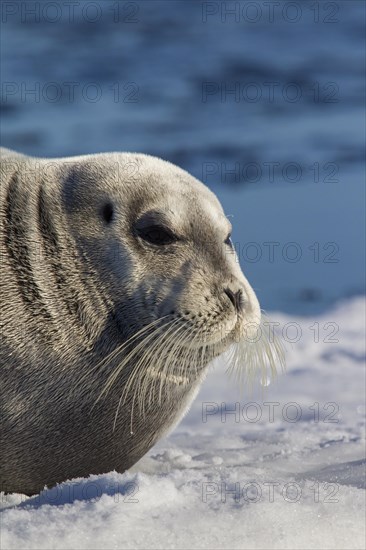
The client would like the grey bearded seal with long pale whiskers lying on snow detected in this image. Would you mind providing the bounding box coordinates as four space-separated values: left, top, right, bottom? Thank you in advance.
1 149 284 495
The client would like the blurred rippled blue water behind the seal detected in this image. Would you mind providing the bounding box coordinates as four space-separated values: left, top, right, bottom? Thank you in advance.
1 0 365 314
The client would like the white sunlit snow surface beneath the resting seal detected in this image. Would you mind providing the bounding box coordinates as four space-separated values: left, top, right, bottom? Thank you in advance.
1 298 365 550
